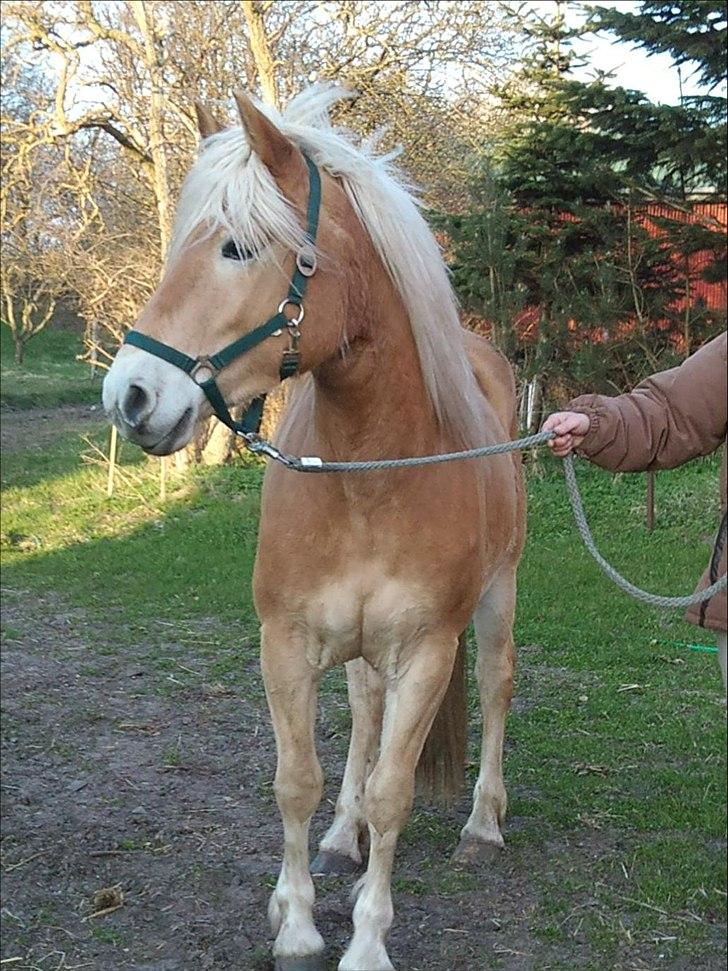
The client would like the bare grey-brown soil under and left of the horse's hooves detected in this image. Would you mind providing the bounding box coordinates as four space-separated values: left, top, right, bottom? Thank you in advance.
2 591 720 971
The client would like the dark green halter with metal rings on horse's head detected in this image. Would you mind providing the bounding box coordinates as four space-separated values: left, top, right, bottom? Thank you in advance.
123 155 321 435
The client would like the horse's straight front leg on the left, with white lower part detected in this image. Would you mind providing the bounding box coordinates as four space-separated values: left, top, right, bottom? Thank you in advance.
261 623 324 971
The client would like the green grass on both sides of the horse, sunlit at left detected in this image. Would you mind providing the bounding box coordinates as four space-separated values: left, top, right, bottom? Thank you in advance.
3 358 726 968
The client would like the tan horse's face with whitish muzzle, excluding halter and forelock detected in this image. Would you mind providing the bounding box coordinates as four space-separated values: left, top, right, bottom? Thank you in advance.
103 98 357 455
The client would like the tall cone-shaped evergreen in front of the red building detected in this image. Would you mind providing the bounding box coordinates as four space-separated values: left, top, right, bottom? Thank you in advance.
494 5 676 396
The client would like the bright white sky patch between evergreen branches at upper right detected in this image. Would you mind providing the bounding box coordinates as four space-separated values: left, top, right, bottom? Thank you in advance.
527 0 728 104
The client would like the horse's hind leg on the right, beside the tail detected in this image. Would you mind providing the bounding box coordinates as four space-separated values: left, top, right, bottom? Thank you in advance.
455 566 516 862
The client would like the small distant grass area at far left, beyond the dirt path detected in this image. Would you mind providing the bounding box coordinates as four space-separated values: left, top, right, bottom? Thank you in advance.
0 324 101 408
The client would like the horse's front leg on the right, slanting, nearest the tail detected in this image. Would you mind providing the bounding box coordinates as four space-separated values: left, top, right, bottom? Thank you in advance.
339 636 458 971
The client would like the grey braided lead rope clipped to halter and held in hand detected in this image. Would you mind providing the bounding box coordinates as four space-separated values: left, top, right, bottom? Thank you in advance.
241 432 728 609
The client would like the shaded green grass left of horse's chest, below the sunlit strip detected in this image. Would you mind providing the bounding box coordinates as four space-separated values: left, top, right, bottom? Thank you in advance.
3 465 260 624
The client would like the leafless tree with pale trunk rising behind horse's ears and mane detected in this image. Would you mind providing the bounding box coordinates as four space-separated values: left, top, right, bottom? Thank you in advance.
235 0 518 208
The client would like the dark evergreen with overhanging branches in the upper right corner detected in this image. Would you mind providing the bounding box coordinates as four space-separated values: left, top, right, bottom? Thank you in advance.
576 0 728 353
